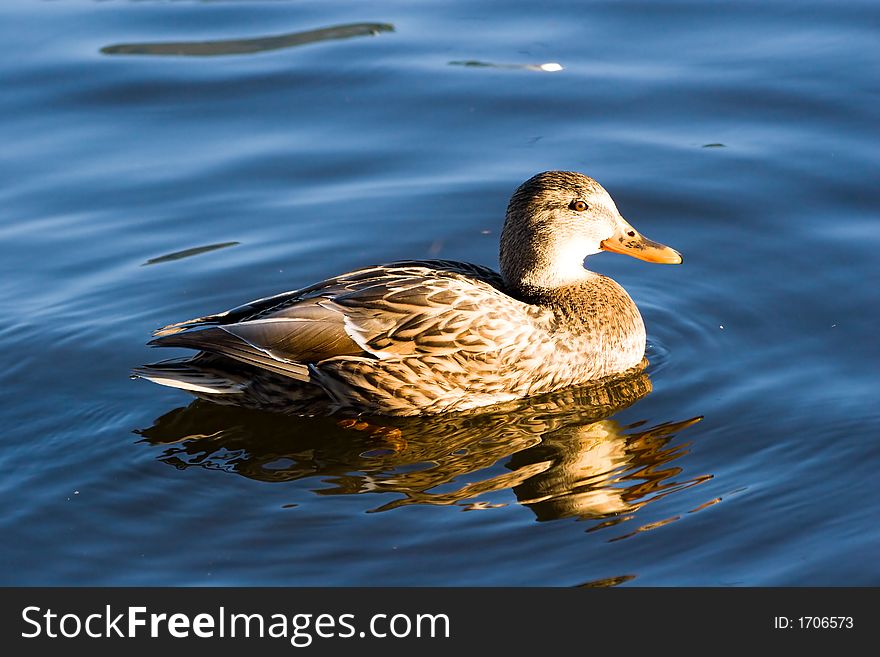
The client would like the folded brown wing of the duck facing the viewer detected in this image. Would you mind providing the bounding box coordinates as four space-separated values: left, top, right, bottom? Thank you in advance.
150 261 549 381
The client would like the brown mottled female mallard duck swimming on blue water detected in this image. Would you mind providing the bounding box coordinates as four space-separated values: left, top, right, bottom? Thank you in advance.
135 171 681 415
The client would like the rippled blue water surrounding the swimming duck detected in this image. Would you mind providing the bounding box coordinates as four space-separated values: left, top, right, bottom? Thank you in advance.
0 0 880 586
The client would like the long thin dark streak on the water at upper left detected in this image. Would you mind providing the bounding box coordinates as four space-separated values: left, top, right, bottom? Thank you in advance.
101 23 394 57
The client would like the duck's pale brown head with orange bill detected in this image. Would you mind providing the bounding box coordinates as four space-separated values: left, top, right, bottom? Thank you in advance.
501 171 681 289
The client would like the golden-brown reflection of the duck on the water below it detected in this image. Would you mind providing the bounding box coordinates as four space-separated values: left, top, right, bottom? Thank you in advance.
136 373 711 526
